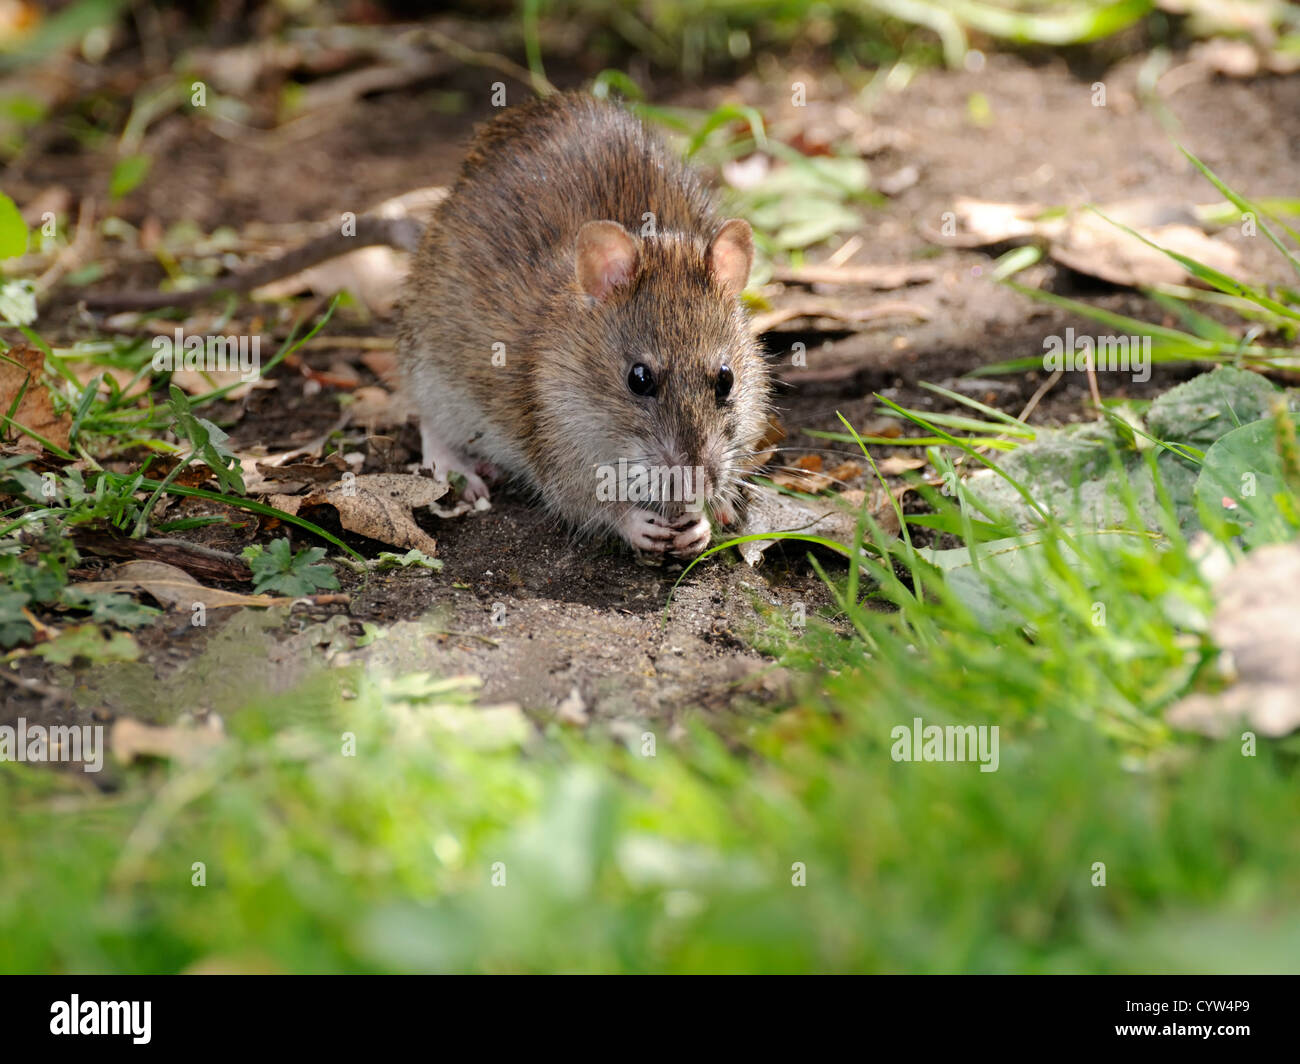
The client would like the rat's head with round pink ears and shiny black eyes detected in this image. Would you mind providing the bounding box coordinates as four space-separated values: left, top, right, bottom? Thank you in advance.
553 220 770 524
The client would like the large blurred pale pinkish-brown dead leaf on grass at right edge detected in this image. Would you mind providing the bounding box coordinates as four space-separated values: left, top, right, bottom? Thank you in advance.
1166 542 1300 739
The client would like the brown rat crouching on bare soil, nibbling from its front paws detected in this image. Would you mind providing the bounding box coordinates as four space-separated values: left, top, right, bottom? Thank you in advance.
398 94 770 557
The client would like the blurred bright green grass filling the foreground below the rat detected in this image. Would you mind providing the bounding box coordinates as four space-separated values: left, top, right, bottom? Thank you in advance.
0 374 1300 972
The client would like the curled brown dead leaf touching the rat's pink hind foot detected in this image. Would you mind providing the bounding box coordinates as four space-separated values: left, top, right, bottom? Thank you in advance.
268 473 460 555
